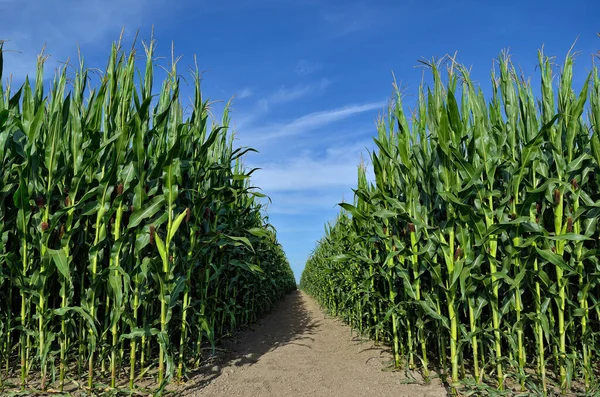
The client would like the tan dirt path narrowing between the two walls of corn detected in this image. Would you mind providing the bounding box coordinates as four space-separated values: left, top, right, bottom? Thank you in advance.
177 291 447 397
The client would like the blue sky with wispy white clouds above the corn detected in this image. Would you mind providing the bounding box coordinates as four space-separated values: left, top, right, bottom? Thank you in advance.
0 0 600 278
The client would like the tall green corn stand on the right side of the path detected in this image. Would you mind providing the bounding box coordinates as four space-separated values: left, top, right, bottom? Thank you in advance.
300 51 600 395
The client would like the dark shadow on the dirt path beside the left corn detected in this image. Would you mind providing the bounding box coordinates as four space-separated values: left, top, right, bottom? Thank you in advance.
168 290 321 395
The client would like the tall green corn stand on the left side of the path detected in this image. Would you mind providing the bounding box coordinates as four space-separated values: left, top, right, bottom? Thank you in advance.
0 40 296 392
